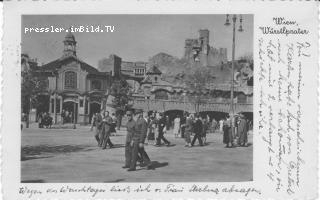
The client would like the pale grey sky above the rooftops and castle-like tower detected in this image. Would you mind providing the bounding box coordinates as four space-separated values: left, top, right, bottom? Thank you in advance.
21 15 253 67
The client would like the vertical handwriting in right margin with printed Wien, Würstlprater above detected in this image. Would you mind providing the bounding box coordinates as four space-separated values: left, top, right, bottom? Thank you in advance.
256 17 311 195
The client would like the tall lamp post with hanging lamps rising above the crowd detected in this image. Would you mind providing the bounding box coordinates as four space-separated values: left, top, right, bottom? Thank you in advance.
224 14 243 136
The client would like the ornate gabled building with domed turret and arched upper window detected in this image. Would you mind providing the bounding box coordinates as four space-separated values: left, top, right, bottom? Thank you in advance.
30 33 112 124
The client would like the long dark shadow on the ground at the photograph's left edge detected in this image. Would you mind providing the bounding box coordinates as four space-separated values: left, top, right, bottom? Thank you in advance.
21 145 93 161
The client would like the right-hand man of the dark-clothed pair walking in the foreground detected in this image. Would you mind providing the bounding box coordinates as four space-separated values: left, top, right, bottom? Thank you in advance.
128 110 151 171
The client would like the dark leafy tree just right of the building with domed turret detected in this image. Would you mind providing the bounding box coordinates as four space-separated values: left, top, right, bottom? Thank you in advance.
110 79 132 129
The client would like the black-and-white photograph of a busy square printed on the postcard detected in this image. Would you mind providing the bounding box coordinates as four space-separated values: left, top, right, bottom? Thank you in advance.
20 13 257 183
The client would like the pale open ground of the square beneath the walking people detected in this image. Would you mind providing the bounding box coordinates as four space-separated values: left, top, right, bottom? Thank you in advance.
21 125 253 182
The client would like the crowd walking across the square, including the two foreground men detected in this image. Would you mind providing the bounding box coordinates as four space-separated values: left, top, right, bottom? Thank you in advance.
91 110 250 171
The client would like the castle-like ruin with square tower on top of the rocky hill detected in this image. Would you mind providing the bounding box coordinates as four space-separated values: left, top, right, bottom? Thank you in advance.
184 29 227 66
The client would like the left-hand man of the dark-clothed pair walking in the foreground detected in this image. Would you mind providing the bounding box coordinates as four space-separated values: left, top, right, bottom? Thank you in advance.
122 111 136 168
